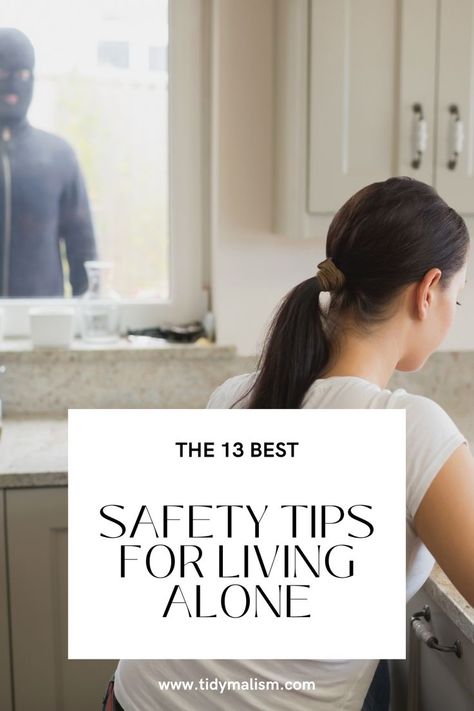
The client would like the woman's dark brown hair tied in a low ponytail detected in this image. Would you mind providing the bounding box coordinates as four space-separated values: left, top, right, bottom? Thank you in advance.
234 177 469 409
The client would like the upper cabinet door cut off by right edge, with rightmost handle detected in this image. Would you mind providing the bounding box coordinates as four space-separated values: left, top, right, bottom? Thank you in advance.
436 0 474 215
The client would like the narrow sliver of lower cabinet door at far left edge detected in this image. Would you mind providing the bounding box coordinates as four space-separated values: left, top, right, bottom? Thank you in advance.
0 489 13 711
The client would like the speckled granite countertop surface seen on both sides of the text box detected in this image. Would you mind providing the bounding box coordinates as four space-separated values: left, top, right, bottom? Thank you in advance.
0 417 474 644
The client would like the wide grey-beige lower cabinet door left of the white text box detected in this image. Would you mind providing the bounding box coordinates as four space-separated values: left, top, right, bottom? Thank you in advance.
7 488 116 711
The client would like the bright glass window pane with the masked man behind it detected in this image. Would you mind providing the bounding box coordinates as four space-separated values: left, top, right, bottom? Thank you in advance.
0 0 169 299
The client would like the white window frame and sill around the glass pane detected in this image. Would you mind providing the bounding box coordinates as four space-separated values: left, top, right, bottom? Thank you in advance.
0 0 210 337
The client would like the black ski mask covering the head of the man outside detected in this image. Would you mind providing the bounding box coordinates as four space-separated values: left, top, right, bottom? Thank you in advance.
0 27 35 125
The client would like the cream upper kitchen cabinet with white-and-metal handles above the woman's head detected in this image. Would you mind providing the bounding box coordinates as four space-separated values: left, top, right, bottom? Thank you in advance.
274 0 474 237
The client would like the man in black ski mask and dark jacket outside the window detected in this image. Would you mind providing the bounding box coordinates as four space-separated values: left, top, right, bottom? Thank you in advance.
0 28 96 297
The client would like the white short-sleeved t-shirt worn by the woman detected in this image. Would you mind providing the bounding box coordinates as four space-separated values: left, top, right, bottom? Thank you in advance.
115 373 466 711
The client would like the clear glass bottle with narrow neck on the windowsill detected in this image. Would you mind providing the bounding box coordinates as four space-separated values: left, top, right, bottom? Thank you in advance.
80 260 120 344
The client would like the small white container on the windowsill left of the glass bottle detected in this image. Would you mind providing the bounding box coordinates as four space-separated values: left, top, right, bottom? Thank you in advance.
28 306 74 348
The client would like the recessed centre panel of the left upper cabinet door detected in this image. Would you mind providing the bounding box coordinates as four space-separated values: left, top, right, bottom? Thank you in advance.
308 0 400 213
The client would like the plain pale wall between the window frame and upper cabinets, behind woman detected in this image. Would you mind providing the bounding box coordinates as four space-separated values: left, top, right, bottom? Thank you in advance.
212 0 474 355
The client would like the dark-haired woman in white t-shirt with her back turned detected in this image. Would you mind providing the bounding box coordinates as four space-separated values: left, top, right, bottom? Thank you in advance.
108 178 474 711
